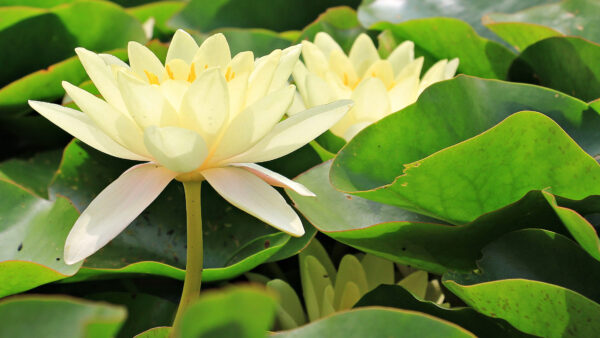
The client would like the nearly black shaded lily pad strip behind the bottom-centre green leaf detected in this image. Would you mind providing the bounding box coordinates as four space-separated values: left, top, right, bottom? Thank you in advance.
354 285 528 338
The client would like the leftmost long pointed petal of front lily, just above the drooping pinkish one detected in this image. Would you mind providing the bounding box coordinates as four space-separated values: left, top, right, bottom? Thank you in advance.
29 101 148 161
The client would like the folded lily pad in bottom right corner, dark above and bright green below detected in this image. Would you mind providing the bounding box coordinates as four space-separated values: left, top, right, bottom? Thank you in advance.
444 230 600 337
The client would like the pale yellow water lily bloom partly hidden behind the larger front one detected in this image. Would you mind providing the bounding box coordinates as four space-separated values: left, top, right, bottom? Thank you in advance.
288 32 458 141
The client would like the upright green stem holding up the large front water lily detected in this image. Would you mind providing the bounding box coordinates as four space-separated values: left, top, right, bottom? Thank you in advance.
173 181 204 335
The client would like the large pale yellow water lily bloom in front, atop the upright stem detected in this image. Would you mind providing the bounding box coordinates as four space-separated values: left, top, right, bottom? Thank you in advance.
29 30 351 264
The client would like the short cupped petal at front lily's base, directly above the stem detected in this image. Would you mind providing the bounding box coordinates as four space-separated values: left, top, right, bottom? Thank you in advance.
144 126 208 173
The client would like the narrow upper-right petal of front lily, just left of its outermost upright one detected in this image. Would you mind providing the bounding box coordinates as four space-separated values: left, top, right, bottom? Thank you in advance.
246 49 281 106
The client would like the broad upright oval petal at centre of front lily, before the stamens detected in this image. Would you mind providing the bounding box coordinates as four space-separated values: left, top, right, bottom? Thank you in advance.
180 68 229 145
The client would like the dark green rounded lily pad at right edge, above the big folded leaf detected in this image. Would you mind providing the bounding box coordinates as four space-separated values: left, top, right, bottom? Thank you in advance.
510 37 600 101
